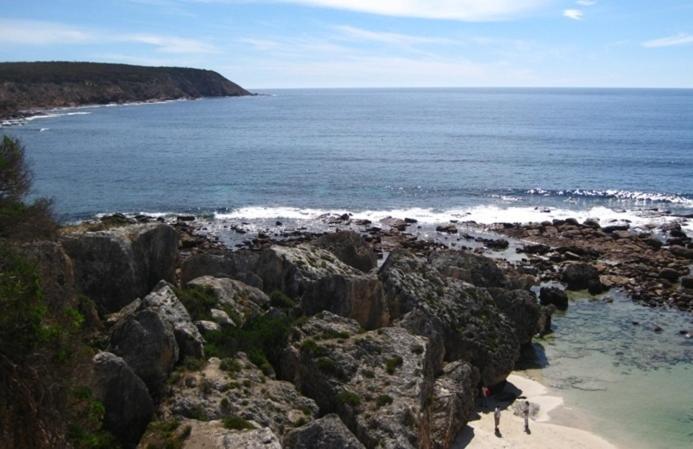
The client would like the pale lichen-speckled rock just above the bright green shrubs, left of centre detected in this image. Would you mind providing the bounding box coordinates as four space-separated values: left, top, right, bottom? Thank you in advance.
188 276 270 326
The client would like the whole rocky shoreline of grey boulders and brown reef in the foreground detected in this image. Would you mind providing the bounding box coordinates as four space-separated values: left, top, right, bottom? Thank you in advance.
21 210 692 449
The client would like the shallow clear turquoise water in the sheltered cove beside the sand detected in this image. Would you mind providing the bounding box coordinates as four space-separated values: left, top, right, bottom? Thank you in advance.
528 297 693 449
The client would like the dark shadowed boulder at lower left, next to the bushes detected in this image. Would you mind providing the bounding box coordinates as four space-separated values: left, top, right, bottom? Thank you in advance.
92 352 154 448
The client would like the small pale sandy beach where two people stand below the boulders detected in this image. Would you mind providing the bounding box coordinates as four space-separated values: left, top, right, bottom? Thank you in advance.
455 374 617 449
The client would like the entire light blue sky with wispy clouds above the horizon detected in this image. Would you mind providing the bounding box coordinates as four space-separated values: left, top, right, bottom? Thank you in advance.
0 0 693 89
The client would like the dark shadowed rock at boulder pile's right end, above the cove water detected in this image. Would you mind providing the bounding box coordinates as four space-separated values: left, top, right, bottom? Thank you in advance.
488 288 540 344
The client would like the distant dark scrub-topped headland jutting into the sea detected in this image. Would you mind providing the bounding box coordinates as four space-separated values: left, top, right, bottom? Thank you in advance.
0 62 250 117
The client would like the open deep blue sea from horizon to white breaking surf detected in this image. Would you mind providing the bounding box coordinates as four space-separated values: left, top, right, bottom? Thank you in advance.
2 89 693 221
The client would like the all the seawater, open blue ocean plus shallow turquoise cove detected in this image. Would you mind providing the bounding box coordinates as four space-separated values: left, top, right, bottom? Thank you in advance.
0 89 693 448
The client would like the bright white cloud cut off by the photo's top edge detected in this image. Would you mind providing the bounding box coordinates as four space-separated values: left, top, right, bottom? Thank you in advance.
185 0 551 22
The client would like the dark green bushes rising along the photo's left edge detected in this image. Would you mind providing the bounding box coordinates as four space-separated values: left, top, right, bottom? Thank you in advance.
0 137 117 449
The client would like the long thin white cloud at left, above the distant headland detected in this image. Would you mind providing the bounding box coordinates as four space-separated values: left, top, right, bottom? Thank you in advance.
0 19 218 54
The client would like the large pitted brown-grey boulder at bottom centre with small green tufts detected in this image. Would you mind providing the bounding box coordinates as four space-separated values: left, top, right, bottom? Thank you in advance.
282 312 433 449
